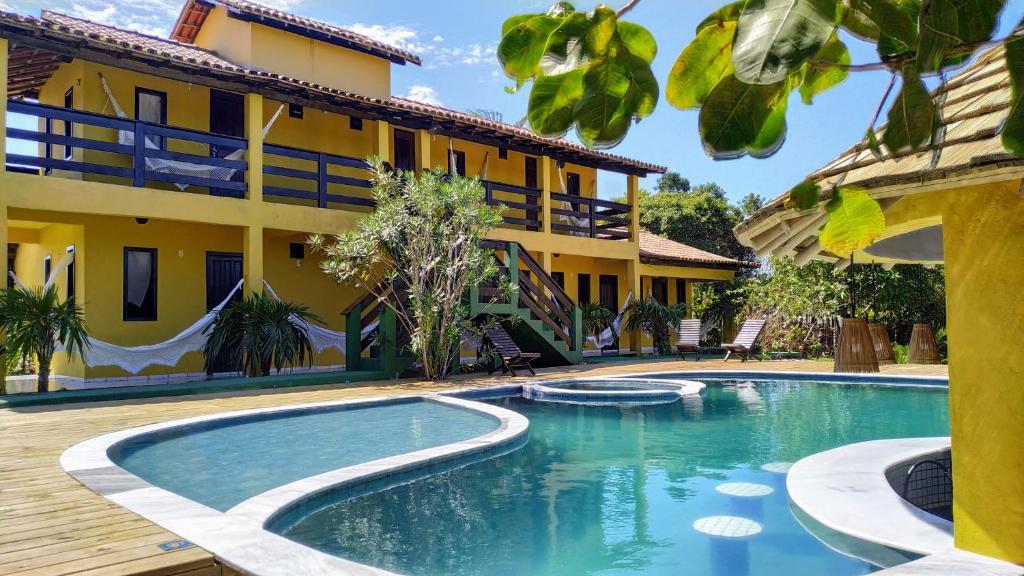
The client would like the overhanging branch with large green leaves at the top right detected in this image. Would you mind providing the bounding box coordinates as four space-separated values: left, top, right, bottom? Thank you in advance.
498 0 1024 255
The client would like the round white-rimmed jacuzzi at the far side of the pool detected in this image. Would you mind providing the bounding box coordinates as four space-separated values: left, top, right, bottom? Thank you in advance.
522 378 705 405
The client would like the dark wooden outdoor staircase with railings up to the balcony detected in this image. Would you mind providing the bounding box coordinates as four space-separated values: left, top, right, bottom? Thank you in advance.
470 240 584 366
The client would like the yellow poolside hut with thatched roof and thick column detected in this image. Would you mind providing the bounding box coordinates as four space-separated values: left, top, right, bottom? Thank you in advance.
735 48 1024 564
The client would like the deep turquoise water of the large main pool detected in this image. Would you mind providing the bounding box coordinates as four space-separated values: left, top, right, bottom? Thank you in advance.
270 382 949 576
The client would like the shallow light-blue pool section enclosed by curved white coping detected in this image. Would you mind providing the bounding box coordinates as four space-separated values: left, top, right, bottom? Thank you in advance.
111 400 500 511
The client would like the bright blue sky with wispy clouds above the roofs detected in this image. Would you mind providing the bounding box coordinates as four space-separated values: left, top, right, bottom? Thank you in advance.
9 0 1024 200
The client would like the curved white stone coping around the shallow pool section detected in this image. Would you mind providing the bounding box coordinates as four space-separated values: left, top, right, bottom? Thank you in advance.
59 395 528 576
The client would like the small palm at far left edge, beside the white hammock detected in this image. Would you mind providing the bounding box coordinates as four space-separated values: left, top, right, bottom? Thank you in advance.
0 285 89 393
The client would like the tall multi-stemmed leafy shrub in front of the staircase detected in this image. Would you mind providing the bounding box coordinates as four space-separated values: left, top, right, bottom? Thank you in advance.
310 158 508 380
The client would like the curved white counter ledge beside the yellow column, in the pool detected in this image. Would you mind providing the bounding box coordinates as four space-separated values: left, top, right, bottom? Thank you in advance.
785 437 953 557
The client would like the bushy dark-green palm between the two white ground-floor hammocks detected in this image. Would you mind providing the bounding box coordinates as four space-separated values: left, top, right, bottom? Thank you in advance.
203 293 324 376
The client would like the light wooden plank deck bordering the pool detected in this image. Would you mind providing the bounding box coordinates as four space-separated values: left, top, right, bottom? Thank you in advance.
0 361 946 576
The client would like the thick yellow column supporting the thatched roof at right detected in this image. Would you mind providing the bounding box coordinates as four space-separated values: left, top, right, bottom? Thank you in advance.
942 180 1024 564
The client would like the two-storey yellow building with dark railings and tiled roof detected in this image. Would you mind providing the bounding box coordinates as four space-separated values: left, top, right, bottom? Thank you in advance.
0 0 748 387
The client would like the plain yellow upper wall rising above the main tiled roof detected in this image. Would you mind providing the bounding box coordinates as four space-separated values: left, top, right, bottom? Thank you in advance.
196 6 391 99
